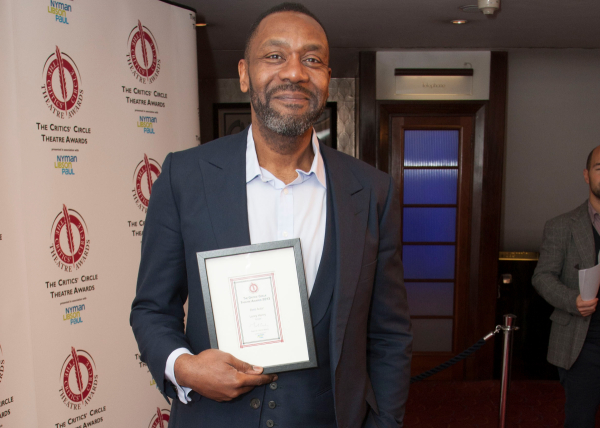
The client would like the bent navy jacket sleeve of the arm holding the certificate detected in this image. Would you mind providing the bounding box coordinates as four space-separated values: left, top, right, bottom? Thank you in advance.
130 153 190 398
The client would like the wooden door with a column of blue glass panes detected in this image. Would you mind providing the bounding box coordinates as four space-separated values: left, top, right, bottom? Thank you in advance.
389 115 474 380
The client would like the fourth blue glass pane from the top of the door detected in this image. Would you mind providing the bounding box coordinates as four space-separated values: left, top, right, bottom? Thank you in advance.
402 245 456 280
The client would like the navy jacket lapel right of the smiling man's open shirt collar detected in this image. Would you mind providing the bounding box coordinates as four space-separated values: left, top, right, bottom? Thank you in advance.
321 145 370 369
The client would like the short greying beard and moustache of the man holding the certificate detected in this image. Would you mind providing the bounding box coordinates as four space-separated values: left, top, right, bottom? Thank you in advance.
249 81 326 137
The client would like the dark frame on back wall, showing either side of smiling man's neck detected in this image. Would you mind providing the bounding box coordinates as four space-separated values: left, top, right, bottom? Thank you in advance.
213 101 337 150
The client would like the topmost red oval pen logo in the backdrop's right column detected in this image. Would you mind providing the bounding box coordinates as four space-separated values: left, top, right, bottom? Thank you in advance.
127 20 160 83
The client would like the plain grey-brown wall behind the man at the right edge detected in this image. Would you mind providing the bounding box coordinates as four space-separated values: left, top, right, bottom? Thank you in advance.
501 49 600 251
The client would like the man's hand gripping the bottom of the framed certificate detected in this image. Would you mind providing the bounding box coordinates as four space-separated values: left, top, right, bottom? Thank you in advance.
174 349 277 401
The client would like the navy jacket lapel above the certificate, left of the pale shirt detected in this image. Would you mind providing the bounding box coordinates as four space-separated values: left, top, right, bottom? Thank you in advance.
198 129 250 248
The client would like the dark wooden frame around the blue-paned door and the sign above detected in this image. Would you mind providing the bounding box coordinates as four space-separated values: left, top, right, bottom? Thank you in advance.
358 52 508 380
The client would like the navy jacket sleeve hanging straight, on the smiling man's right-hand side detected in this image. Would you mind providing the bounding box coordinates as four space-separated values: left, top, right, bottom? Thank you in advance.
365 178 412 428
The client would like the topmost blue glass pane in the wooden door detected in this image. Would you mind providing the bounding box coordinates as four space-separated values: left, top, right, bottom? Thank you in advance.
404 129 459 166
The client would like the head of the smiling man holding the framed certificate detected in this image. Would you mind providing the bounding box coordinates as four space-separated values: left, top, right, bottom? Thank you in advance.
238 12 331 137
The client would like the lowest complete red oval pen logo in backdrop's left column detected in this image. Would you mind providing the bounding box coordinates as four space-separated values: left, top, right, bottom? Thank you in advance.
60 347 98 409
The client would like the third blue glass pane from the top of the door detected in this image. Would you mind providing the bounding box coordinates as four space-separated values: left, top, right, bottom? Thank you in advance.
402 208 456 242
